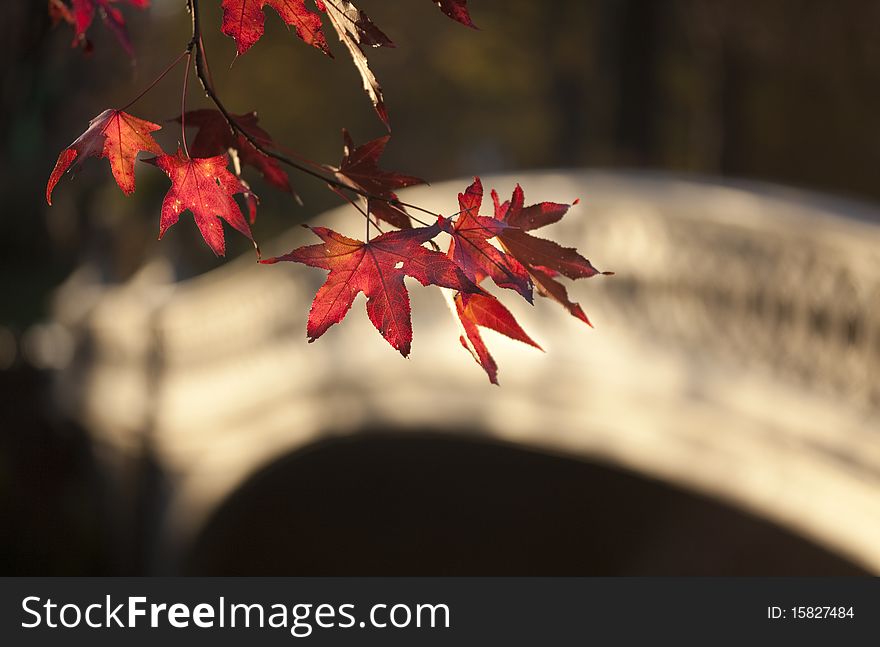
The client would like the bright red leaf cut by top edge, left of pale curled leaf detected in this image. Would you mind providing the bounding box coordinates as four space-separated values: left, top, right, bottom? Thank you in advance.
220 0 330 55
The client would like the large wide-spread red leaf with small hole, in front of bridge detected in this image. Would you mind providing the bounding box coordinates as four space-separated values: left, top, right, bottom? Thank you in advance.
260 225 482 357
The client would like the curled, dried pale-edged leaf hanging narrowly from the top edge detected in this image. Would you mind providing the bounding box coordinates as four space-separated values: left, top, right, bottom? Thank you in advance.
315 0 394 130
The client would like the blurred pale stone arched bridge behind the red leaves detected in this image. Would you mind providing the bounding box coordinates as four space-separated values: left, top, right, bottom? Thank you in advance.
49 171 880 573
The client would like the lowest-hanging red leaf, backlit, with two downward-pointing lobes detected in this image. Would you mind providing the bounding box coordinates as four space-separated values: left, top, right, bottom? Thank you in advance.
454 292 541 384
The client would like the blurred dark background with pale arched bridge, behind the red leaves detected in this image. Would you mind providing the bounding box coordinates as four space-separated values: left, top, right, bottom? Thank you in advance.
0 0 880 575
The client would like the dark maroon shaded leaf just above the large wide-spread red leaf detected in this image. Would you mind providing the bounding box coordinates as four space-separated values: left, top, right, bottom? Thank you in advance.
334 129 425 229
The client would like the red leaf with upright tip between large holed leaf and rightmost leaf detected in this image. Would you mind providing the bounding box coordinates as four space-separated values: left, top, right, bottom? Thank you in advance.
437 178 532 303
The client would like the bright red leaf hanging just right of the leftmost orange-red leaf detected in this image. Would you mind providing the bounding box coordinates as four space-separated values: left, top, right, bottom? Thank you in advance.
144 148 259 256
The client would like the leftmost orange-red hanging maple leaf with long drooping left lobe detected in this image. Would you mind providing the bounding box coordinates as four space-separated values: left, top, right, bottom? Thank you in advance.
46 109 162 204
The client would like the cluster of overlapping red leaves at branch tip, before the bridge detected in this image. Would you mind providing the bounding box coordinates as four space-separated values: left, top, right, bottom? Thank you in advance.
261 178 599 384
